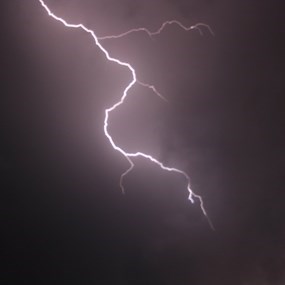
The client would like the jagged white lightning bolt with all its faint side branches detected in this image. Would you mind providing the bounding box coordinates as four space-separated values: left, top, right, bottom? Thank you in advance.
38 0 214 229
